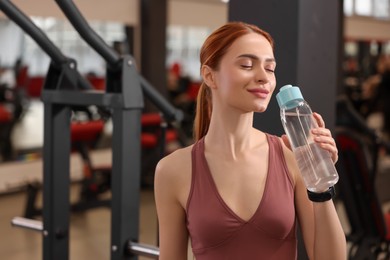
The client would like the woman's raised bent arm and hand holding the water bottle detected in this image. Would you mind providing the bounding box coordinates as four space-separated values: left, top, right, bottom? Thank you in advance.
283 113 347 260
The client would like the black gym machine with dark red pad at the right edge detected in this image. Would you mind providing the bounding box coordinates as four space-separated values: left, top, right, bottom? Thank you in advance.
335 97 390 260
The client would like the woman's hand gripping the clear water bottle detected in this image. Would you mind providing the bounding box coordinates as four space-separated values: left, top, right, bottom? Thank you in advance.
282 113 339 163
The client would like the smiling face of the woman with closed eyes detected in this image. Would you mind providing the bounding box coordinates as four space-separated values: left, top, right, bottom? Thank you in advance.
212 33 276 112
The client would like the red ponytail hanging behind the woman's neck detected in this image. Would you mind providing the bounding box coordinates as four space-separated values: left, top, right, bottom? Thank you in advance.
193 82 212 141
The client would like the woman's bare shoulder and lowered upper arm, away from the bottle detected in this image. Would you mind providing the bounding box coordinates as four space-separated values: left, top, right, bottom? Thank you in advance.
154 146 193 259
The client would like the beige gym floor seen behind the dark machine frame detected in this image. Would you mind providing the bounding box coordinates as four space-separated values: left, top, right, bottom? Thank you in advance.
0 185 157 260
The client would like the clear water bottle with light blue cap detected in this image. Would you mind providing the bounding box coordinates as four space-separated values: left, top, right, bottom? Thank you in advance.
276 85 339 192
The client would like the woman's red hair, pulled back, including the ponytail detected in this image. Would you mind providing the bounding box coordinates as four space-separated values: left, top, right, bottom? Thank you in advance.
193 22 274 141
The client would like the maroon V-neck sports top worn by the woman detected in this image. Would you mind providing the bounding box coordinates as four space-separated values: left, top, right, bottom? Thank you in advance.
186 134 297 260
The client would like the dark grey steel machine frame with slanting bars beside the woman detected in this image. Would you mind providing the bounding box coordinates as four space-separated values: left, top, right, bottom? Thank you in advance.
0 0 183 260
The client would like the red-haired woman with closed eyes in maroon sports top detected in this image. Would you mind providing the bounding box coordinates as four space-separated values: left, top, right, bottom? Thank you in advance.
155 22 346 260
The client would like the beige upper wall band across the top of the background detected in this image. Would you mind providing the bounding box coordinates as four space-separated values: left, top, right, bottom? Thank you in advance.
0 0 390 40
